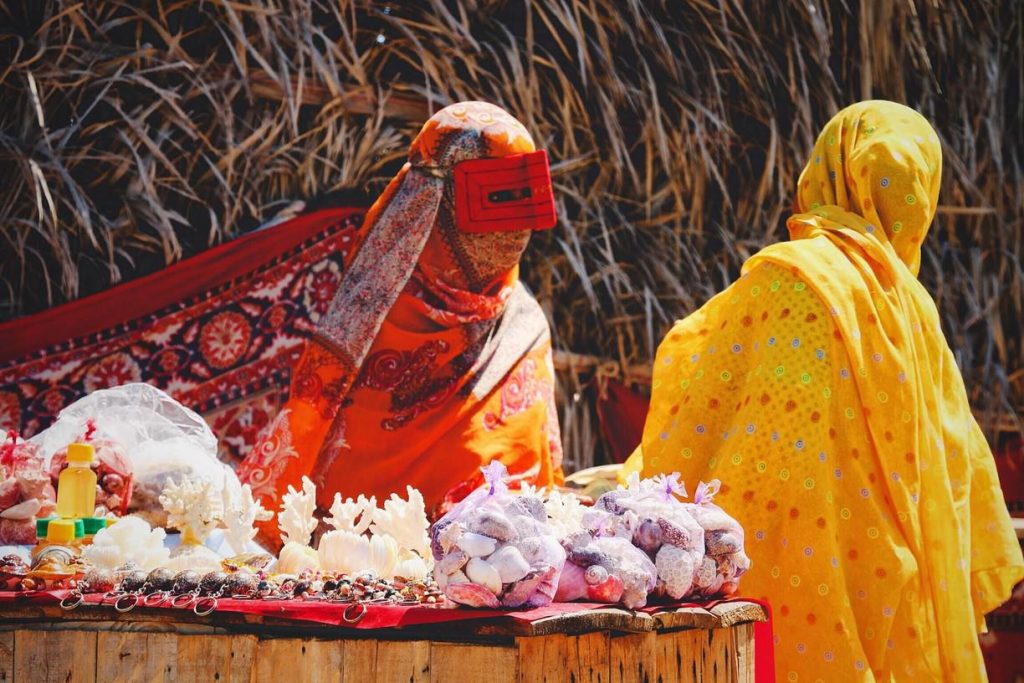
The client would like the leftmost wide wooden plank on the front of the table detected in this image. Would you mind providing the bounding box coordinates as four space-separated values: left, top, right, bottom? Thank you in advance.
14 630 96 683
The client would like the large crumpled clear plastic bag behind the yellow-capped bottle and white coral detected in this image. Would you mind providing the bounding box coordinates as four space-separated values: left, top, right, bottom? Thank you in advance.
31 383 241 526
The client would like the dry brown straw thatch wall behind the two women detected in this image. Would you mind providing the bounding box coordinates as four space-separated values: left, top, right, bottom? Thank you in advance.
0 0 1024 465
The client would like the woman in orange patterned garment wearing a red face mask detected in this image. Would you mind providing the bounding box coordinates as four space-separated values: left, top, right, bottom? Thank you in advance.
239 102 562 528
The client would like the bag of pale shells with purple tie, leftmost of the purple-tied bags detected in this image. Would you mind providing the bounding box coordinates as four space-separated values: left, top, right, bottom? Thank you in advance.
430 461 565 608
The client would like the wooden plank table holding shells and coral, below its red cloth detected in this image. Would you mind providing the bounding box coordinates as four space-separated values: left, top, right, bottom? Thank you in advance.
0 602 765 683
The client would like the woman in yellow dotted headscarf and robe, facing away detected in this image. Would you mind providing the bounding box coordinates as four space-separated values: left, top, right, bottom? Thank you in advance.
626 101 1024 682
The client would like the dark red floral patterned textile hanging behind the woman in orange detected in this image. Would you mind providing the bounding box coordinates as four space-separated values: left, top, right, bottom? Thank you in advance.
0 208 364 462
